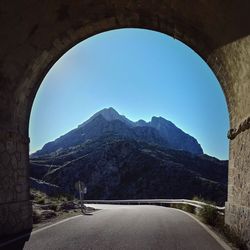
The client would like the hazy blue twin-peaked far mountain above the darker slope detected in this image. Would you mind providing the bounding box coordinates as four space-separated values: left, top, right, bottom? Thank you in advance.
31 108 203 157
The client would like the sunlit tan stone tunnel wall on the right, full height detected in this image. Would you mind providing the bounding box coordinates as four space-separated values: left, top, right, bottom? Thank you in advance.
213 36 250 249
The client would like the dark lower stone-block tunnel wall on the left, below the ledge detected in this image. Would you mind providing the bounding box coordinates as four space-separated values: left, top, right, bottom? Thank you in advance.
0 129 32 236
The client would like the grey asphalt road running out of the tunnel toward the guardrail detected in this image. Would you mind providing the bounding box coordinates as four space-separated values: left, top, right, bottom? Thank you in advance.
1 205 229 250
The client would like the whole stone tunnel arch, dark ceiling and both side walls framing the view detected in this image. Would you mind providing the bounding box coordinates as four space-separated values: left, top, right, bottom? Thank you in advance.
0 0 250 246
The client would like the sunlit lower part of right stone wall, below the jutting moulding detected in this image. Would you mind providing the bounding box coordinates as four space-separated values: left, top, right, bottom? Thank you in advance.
225 129 250 249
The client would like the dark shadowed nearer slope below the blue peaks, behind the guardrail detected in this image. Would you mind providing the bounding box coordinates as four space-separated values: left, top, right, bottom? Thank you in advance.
31 135 227 204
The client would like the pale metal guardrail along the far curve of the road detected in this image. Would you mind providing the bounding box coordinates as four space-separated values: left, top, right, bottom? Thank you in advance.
84 199 225 213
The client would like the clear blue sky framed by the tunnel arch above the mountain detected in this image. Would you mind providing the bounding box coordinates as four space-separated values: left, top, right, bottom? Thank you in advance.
29 29 229 159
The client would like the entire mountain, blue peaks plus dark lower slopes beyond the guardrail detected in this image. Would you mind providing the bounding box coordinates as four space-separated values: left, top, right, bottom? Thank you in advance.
30 108 227 204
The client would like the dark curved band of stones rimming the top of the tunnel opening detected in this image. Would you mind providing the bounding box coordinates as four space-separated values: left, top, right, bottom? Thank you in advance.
15 15 231 137
